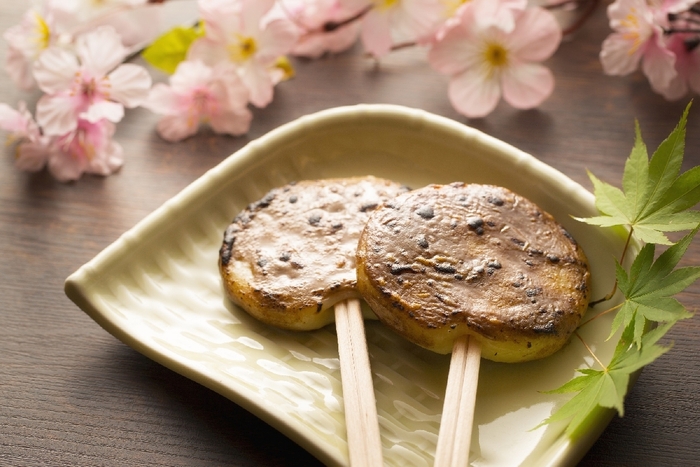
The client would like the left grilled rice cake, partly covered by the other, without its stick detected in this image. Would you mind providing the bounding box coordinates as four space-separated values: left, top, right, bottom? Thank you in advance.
219 176 408 330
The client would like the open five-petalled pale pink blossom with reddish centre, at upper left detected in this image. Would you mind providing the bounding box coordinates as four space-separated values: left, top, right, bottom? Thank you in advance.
34 26 151 135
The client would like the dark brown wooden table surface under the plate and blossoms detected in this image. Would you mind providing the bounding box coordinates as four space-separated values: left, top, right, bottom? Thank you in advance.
0 2 700 467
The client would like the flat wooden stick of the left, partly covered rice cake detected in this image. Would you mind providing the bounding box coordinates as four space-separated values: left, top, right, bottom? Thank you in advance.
335 299 383 466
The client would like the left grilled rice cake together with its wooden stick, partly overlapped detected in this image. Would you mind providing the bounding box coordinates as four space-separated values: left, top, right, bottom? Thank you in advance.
219 176 408 465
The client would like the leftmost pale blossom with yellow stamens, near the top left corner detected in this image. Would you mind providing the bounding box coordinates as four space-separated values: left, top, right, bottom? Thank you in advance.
3 8 57 91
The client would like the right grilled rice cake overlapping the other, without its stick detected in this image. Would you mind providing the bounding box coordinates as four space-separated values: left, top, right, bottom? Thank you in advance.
357 183 590 362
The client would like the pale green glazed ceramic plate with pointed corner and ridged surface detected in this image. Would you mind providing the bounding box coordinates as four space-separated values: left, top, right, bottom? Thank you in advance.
65 105 636 466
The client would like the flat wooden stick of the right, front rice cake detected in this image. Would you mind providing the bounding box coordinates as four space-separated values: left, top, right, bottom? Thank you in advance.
435 336 481 467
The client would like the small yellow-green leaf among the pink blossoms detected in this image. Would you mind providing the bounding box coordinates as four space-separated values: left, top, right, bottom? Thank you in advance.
141 26 204 74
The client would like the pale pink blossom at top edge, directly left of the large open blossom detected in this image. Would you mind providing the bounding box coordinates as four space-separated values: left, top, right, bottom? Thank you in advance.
348 0 445 57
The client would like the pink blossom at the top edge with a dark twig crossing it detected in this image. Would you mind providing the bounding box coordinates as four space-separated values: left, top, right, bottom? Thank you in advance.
271 0 360 58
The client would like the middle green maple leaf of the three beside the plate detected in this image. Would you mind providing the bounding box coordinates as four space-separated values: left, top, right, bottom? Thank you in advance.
610 227 700 345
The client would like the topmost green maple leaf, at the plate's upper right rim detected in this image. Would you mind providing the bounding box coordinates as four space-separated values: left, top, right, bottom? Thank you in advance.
578 104 700 245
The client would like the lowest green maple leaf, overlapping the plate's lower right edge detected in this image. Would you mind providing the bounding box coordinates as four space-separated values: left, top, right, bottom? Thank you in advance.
540 323 673 436
